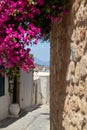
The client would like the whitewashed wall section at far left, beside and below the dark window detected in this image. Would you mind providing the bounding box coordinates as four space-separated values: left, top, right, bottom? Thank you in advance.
0 78 10 120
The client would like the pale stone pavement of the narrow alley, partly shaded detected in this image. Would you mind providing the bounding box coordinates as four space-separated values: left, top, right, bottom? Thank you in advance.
0 105 50 130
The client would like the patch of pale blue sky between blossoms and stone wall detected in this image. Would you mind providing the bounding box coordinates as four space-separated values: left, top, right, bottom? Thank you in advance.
30 42 50 61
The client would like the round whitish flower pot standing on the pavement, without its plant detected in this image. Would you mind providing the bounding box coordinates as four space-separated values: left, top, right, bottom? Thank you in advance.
9 103 20 116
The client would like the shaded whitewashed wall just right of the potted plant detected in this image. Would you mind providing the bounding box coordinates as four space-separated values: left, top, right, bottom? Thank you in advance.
20 71 33 109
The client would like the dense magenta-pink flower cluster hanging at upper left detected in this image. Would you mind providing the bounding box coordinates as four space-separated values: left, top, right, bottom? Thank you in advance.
0 0 41 71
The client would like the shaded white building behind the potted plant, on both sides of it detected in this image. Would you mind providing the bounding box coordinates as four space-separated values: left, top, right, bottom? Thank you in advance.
0 71 33 120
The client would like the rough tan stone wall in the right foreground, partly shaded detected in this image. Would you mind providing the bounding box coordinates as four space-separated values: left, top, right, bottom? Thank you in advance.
50 0 87 130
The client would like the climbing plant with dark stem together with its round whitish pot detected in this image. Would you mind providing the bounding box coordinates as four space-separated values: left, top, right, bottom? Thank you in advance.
8 67 20 116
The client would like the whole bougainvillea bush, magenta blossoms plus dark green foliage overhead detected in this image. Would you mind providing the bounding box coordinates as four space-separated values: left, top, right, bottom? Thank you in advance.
0 0 69 74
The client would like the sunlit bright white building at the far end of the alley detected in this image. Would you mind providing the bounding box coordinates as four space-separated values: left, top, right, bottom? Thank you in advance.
33 71 50 104
